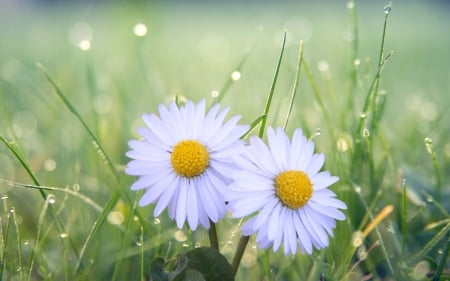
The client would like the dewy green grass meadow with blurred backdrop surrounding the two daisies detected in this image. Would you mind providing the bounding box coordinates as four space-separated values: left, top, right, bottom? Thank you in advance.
0 1 450 280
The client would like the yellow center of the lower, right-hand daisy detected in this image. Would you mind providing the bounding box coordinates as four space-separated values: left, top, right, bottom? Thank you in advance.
275 170 313 209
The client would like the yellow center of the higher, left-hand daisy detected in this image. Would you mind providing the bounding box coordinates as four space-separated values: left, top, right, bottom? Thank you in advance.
170 140 209 178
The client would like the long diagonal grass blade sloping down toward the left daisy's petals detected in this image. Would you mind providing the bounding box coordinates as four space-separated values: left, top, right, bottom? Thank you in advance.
38 64 119 180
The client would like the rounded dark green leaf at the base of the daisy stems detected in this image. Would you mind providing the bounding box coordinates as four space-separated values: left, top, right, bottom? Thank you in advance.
182 247 234 281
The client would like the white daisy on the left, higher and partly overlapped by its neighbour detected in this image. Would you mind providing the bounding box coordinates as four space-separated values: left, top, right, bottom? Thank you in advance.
125 100 249 230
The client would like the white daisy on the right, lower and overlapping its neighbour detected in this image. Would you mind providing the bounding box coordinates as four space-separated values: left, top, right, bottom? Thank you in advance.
227 128 347 255
